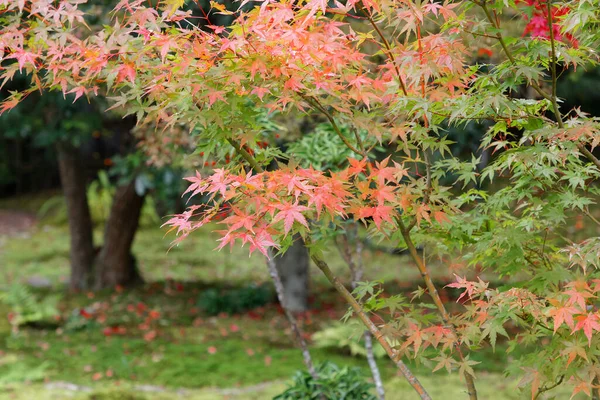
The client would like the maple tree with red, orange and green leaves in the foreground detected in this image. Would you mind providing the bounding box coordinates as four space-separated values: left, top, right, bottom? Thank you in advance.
0 0 600 399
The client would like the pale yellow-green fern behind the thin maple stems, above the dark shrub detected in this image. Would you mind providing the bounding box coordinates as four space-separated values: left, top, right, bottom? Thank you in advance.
312 321 386 358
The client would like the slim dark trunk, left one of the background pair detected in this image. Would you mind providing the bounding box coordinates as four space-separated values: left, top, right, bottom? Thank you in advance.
56 143 94 290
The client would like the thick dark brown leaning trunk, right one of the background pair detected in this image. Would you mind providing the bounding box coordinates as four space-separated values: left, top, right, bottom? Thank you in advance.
94 179 144 289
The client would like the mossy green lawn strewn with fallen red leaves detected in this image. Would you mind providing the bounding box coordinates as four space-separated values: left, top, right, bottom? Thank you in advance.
0 192 580 400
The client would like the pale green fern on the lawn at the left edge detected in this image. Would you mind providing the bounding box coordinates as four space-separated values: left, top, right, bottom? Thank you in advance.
0 284 59 335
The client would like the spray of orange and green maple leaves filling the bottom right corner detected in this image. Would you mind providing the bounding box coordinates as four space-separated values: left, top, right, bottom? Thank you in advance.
450 277 600 397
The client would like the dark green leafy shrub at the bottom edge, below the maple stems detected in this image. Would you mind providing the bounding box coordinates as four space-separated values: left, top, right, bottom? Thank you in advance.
273 362 376 400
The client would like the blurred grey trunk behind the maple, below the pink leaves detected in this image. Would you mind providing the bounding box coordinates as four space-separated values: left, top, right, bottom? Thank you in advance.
275 237 310 312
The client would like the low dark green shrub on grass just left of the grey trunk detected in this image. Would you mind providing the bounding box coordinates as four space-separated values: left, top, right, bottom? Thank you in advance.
198 285 274 315
